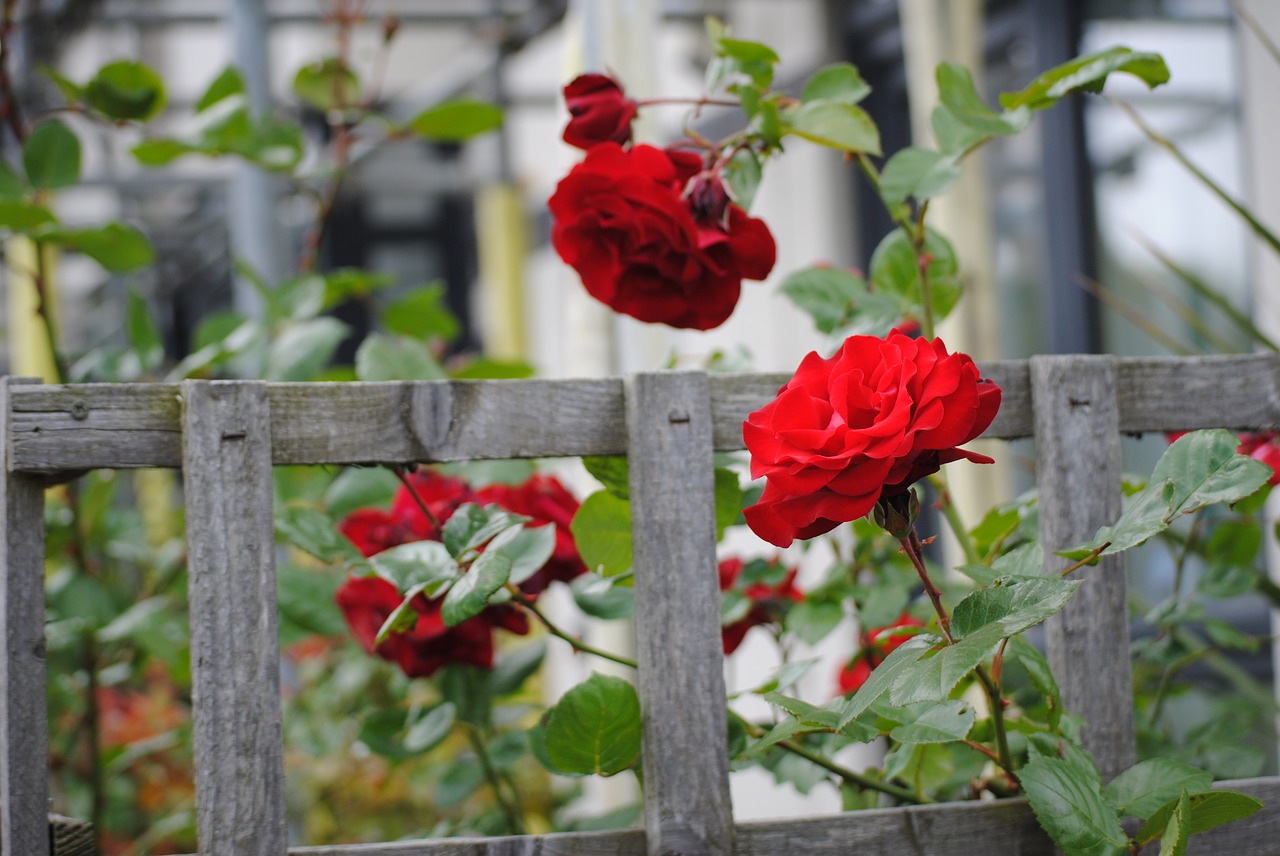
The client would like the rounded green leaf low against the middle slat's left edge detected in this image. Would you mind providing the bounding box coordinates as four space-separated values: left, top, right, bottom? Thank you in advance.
545 672 641 775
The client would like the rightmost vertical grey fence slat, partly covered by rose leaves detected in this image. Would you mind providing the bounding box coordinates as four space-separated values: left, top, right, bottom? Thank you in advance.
1030 356 1134 779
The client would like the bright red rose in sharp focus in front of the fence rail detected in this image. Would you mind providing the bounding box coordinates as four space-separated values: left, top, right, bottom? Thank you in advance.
742 331 1001 546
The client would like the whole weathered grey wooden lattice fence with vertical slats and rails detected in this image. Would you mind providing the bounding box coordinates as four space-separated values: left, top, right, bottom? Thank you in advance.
0 356 1280 856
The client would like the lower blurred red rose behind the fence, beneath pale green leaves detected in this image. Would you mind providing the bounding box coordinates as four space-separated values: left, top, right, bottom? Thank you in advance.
335 577 529 678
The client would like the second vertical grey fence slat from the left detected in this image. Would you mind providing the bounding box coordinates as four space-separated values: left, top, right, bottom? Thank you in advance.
182 381 287 856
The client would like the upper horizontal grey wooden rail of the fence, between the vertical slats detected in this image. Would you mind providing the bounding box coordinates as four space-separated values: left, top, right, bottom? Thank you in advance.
10 354 1280 472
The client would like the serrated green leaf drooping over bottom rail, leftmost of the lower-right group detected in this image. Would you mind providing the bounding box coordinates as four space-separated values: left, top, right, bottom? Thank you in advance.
1018 750 1129 856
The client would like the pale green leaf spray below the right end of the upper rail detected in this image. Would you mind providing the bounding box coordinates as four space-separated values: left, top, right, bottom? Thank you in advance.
1059 429 1272 559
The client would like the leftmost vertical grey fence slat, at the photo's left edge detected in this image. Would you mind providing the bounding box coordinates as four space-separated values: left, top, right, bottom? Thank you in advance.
0 379 49 856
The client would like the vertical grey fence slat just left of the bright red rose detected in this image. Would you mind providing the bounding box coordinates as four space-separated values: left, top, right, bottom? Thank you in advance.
626 371 733 856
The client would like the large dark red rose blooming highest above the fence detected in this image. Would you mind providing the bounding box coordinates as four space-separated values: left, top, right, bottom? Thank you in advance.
548 143 777 330
